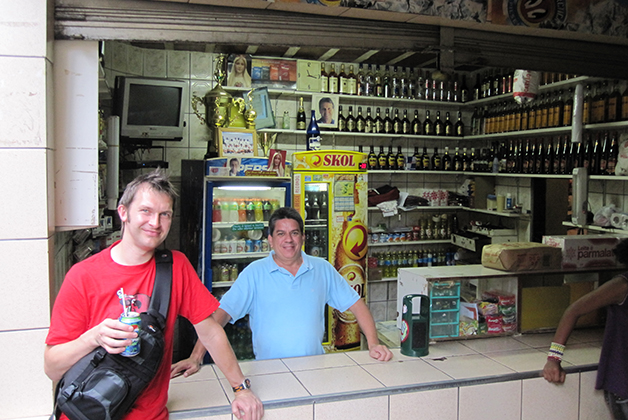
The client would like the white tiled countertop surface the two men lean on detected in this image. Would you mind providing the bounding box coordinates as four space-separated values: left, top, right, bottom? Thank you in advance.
168 329 603 419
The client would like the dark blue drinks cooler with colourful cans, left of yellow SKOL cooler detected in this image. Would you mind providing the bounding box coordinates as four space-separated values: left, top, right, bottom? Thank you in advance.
180 157 292 359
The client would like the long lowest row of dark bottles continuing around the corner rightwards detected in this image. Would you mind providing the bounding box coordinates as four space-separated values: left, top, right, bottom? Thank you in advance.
368 132 619 175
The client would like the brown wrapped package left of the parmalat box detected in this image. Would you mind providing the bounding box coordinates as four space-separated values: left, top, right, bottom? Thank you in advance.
482 242 562 271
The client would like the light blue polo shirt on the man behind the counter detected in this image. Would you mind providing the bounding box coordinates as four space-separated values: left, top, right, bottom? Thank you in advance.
220 252 360 360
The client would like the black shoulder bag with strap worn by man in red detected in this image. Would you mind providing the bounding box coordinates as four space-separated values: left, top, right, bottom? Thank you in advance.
51 250 172 420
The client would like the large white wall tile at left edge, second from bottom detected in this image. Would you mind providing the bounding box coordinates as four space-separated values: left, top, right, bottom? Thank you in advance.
0 239 50 331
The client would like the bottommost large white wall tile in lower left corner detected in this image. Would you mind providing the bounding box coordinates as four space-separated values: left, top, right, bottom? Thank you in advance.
0 329 53 419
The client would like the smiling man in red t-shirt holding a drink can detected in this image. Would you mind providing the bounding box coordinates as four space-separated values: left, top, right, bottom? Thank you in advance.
44 169 264 420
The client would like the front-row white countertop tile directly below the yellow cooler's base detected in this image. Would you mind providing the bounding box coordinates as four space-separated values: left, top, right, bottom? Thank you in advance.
294 366 383 395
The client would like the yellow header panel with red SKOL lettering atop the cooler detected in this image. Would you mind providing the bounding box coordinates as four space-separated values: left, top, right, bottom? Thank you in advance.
292 150 367 172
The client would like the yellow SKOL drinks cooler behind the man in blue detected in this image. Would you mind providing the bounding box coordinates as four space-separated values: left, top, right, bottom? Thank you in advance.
292 150 368 352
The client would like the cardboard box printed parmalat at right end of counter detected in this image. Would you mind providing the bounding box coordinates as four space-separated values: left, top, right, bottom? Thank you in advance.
543 235 623 268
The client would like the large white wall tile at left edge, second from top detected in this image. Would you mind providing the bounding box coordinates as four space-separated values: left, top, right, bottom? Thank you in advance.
0 55 47 148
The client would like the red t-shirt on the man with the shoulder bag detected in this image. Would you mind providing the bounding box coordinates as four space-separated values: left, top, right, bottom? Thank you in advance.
46 243 219 420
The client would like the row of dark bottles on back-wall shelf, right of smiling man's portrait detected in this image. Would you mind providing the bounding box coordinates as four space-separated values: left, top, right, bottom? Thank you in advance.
338 106 464 137
